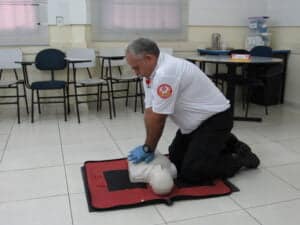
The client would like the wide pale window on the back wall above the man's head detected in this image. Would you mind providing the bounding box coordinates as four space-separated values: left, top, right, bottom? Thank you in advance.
91 0 188 41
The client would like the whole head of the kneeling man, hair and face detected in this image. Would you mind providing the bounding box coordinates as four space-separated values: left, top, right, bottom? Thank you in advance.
126 38 159 78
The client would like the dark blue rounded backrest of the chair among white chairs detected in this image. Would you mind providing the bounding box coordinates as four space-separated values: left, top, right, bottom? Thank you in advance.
35 48 67 71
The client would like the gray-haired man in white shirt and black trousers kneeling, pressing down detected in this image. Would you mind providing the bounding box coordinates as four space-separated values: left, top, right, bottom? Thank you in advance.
126 38 259 192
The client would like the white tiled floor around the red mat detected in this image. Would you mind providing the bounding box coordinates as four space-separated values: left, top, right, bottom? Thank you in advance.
0 102 300 225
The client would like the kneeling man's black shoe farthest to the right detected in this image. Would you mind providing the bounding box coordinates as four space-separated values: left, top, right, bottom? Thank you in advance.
234 141 260 169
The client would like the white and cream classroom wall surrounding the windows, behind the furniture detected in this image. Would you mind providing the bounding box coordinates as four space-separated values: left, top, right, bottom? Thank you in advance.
13 0 300 106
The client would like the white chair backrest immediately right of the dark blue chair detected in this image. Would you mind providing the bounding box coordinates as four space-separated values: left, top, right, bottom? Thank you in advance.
66 48 96 68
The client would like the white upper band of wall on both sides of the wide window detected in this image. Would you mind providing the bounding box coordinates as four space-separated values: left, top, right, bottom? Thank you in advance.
48 0 300 26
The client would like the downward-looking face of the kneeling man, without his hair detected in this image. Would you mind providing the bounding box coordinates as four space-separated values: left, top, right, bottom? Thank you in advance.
126 53 157 77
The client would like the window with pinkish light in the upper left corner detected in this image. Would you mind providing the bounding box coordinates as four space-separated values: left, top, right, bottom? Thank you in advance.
0 0 48 46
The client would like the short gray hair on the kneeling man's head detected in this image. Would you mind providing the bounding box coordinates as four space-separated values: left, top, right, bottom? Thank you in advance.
126 38 159 57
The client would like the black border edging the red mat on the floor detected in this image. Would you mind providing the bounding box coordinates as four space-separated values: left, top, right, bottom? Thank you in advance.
81 158 240 212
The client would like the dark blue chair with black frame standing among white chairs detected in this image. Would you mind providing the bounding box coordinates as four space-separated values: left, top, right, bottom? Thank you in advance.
23 49 67 123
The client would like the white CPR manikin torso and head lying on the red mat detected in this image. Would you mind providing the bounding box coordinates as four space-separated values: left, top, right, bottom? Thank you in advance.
128 152 177 195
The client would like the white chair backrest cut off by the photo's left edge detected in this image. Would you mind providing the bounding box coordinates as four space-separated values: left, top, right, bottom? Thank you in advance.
0 48 23 69
